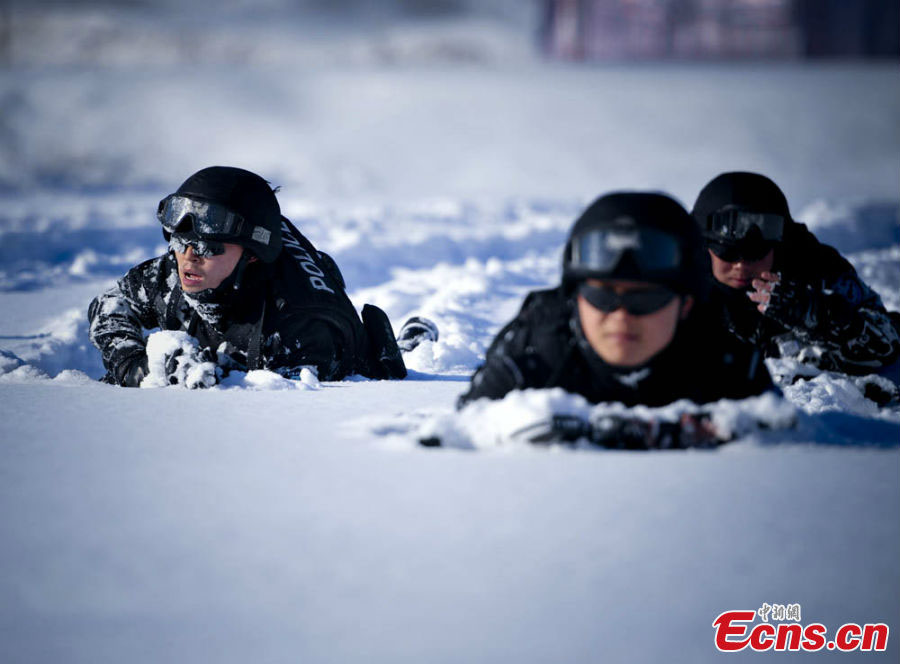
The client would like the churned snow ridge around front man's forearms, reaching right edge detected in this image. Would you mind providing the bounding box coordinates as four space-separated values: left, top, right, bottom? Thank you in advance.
370 381 900 453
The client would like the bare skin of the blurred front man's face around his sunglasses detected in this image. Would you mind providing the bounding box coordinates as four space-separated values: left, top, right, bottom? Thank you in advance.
577 279 693 367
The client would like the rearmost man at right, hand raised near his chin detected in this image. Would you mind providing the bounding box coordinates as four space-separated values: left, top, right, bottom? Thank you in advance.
692 172 900 400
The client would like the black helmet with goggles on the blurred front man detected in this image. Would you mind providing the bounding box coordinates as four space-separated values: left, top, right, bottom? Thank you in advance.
563 192 707 295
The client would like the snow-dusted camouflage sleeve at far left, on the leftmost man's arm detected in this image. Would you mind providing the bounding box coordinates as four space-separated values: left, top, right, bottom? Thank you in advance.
88 259 159 387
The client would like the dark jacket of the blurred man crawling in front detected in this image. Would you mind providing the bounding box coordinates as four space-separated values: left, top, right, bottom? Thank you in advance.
458 287 774 407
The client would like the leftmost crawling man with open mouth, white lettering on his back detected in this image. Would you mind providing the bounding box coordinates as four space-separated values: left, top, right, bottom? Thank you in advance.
88 166 406 387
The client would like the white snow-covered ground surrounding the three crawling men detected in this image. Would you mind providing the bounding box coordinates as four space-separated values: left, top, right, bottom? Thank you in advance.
0 58 900 662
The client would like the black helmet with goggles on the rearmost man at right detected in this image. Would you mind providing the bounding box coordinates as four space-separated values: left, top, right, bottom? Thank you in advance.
691 172 792 257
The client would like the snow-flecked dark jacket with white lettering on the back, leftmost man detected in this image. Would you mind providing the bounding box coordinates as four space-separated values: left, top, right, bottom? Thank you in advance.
88 220 405 386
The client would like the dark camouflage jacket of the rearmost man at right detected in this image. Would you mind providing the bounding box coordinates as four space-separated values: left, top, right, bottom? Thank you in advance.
710 222 900 374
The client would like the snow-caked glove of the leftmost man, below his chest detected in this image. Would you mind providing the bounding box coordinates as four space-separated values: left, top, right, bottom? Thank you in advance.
141 331 218 389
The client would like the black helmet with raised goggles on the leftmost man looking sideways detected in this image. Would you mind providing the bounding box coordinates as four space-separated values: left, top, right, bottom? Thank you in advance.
156 166 281 263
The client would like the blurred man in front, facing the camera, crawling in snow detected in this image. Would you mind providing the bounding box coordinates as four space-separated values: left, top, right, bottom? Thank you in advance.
460 192 775 447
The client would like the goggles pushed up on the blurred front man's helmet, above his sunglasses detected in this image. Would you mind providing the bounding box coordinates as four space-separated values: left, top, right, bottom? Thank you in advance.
570 228 681 273
